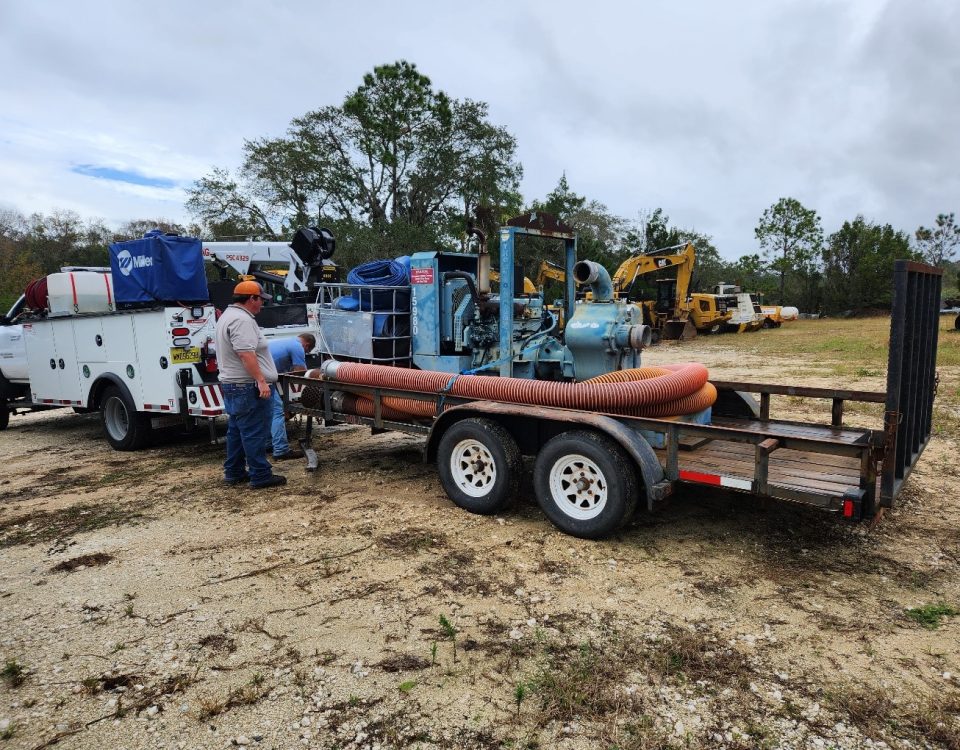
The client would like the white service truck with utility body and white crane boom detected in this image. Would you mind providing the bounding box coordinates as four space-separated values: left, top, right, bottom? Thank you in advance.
0 230 333 450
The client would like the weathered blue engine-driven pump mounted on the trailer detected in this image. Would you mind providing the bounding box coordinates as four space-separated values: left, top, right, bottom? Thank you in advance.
318 213 650 381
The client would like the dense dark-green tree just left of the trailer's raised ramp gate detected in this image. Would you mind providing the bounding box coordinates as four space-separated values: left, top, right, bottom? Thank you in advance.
823 216 913 312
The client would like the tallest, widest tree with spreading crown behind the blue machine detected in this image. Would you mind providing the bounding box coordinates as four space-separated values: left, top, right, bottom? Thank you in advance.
187 61 522 251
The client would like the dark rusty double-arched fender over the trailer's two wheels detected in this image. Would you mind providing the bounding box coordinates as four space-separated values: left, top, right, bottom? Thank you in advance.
424 401 672 510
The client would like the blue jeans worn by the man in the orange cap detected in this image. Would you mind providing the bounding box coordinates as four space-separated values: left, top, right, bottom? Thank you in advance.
220 383 273 484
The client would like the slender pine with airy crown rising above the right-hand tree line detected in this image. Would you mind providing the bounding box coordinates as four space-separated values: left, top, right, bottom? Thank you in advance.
754 198 823 305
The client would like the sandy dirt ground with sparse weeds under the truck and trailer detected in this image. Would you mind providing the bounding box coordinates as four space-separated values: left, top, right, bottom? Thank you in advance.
0 324 960 750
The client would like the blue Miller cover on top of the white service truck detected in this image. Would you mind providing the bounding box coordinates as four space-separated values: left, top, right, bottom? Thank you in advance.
110 230 210 305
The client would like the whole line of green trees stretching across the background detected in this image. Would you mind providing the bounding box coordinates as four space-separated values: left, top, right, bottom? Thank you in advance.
0 61 960 314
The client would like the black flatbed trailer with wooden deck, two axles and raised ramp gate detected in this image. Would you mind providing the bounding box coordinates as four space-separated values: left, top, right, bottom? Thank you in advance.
282 261 942 538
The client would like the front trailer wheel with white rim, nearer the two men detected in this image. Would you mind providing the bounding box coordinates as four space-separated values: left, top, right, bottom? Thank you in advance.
437 419 522 515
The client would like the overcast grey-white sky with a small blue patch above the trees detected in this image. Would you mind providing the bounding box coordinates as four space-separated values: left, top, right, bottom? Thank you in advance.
0 0 960 259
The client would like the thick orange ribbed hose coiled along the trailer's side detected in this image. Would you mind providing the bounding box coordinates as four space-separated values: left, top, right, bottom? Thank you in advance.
305 361 716 418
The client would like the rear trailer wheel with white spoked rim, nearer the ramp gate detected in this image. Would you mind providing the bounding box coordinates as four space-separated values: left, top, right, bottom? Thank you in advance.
533 430 639 539
